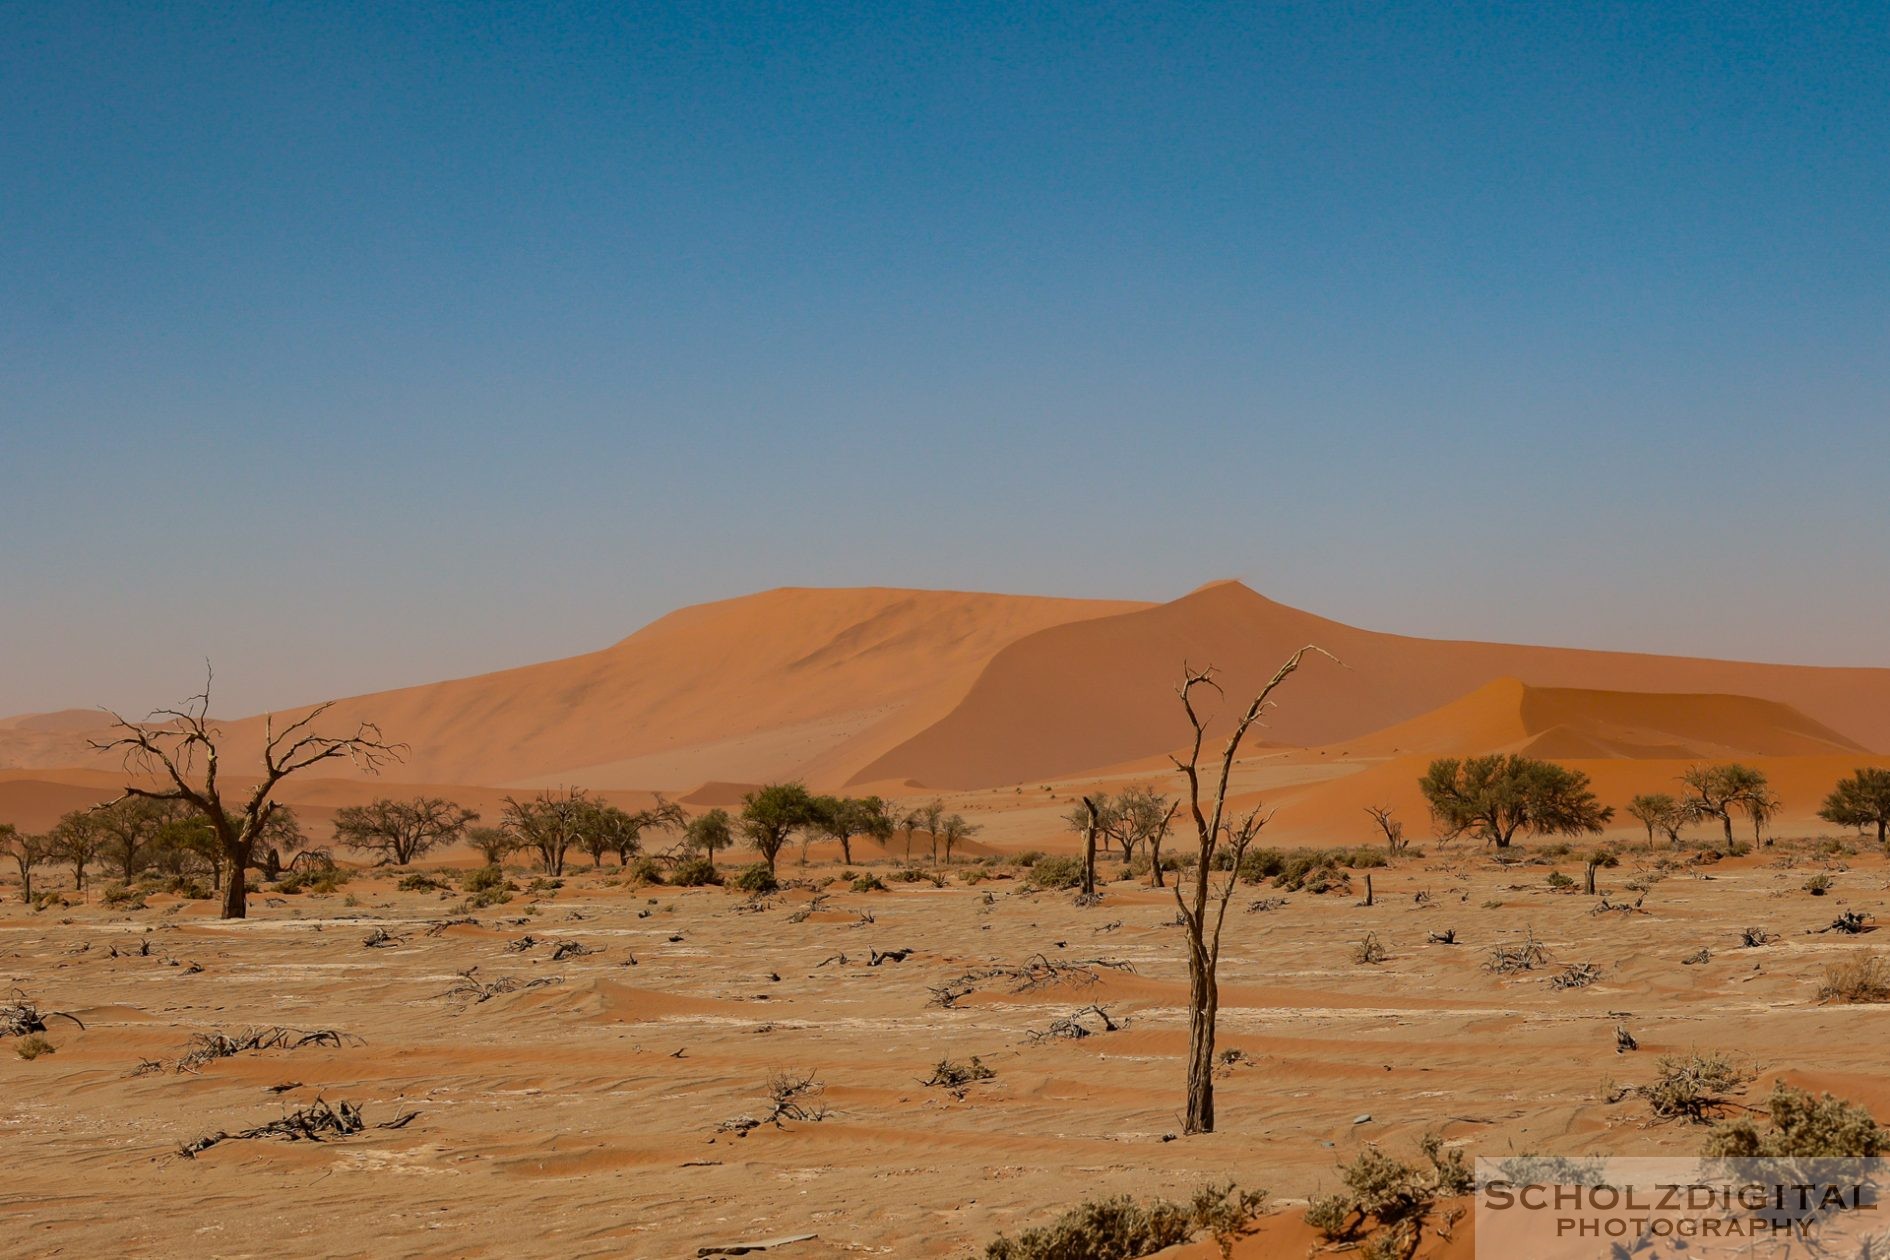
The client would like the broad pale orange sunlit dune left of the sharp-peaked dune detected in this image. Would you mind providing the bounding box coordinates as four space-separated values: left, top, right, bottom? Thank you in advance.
0 587 1140 788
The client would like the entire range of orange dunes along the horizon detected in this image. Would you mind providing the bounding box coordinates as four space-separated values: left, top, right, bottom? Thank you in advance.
0 582 1890 799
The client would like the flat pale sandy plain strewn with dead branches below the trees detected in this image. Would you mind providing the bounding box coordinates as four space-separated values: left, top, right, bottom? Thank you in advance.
0 848 1890 1260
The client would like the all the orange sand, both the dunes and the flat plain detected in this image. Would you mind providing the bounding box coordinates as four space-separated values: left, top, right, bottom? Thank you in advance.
0 584 1890 1258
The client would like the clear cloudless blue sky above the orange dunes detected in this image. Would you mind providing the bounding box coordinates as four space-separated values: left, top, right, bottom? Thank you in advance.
0 0 1890 712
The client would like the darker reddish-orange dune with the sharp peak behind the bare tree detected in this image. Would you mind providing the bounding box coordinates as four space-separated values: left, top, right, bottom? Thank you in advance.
858 582 1890 788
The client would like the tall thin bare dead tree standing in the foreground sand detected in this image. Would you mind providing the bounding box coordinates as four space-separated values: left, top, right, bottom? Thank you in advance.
1172 644 1338 1133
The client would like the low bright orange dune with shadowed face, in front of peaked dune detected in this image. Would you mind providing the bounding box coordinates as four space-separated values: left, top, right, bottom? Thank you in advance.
1346 678 1864 759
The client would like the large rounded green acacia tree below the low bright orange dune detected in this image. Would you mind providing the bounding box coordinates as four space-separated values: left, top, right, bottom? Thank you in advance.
1418 754 1614 848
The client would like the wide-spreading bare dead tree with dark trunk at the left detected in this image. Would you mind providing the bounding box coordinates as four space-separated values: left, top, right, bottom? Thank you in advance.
93 671 406 918
